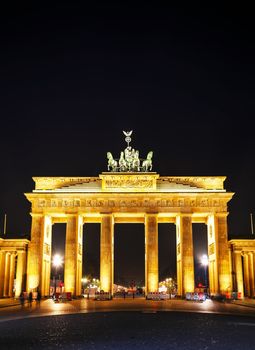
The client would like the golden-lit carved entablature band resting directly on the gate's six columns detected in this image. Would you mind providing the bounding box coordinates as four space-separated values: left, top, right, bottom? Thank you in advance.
26 192 233 213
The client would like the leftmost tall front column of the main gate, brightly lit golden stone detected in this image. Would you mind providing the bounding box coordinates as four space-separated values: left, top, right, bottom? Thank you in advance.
27 214 44 291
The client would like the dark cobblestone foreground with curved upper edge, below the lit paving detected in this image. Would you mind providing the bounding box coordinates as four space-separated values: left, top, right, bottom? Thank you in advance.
0 311 255 350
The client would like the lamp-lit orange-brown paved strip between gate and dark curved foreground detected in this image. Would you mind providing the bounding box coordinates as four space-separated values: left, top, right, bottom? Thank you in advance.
0 298 255 323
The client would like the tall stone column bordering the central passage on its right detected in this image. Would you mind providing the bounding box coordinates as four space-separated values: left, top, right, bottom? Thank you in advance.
145 214 158 294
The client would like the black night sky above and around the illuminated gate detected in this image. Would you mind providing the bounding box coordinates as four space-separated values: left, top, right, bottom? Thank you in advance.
0 2 255 284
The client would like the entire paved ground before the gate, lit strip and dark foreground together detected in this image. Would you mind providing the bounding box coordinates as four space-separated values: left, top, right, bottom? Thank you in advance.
0 299 255 350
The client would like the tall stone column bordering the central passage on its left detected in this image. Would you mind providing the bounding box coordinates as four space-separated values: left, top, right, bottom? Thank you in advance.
100 214 114 293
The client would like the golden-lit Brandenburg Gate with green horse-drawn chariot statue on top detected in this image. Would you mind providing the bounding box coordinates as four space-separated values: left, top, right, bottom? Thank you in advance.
25 132 233 296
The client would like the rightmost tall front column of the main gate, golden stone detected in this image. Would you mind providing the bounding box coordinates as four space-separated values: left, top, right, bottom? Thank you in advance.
216 213 232 294
